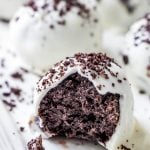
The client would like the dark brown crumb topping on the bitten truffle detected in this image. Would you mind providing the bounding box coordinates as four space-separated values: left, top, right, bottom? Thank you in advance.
37 53 120 91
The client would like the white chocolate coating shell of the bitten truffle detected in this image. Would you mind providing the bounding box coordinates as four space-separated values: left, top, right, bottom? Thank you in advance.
34 54 134 150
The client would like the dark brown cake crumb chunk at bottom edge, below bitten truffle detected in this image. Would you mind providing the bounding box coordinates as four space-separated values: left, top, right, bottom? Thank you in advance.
27 136 44 150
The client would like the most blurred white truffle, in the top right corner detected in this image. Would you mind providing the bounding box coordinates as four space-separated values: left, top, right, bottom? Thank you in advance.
100 0 150 29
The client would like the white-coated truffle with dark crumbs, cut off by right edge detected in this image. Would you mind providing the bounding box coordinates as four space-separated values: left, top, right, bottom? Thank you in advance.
123 14 150 93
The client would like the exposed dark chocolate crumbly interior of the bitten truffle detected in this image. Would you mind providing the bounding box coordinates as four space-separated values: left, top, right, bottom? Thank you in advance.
38 73 120 143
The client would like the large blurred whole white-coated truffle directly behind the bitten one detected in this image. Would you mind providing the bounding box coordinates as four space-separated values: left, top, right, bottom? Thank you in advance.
10 0 101 74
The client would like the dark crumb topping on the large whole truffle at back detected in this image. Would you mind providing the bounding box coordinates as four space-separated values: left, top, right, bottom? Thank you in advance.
22 0 100 30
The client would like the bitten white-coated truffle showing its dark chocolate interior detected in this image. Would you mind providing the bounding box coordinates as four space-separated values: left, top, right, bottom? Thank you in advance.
34 53 134 150
